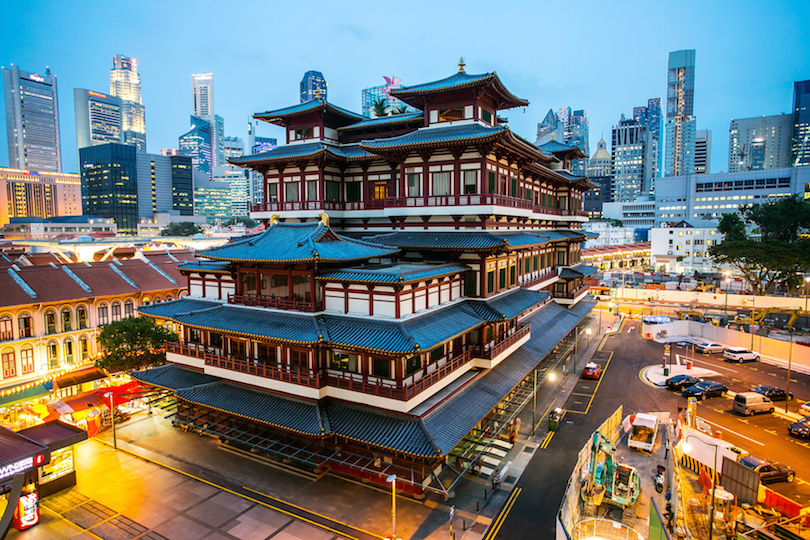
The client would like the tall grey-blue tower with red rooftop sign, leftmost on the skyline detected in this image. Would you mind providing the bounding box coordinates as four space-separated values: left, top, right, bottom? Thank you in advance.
3 65 62 171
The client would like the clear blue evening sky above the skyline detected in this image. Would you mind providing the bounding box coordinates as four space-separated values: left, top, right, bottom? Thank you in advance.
0 0 810 172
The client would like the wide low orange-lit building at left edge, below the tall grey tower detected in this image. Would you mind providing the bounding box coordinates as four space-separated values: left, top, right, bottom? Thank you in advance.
0 168 82 226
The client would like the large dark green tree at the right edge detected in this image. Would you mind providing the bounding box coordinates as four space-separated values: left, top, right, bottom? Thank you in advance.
709 196 810 294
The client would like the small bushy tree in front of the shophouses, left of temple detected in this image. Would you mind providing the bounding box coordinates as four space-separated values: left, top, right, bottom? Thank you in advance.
96 317 177 372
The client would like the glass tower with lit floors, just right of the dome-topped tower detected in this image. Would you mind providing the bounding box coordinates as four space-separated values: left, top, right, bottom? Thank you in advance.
610 115 653 202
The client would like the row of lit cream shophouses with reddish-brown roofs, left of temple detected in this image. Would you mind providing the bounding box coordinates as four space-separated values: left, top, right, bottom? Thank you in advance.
0 252 193 405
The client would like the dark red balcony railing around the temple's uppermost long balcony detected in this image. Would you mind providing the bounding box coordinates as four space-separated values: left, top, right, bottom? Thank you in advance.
250 193 588 217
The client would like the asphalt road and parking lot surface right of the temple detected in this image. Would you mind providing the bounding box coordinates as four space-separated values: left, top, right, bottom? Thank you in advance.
497 320 810 539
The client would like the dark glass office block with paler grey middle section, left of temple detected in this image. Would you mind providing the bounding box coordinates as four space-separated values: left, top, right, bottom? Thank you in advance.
79 143 193 234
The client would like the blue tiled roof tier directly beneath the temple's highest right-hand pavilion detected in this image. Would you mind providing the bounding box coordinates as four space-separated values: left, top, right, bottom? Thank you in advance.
360 122 509 152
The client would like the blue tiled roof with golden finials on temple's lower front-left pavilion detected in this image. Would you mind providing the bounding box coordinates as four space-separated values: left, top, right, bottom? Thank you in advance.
198 222 399 264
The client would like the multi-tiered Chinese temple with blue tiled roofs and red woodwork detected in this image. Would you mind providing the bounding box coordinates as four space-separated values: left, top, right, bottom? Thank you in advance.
133 63 595 497
